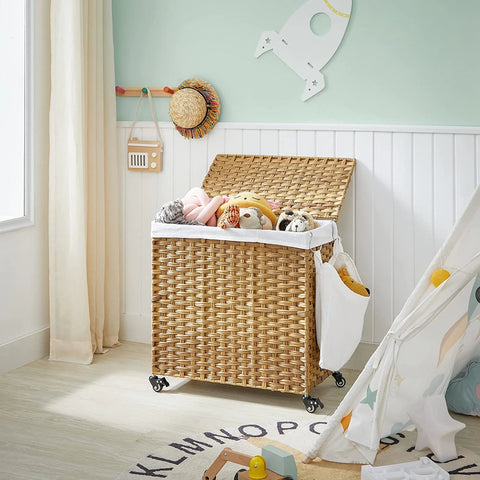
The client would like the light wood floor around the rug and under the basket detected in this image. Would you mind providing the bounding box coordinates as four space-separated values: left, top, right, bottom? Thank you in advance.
0 343 480 480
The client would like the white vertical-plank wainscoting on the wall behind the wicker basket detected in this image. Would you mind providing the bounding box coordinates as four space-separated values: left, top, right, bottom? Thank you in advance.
118 122 480 343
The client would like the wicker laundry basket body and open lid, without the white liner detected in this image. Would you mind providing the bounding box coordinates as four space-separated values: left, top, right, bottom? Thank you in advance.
151 155 355 408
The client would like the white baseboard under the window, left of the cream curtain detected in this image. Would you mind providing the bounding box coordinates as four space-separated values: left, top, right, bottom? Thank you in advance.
0 327 50 374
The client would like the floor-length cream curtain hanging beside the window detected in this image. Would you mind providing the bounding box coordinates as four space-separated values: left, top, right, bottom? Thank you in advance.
49 0 120 363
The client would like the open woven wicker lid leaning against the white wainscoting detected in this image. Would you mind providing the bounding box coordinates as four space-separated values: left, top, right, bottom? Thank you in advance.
202 155 355 220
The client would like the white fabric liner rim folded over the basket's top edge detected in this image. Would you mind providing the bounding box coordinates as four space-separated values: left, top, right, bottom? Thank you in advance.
151 220 338 250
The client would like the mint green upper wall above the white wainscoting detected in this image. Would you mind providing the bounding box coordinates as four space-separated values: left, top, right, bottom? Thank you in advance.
113 0 480 126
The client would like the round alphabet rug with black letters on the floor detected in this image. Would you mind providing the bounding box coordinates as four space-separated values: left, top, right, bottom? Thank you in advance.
118 416 480 480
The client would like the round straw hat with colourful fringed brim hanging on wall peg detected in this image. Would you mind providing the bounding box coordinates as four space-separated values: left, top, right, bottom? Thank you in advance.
168 78 220 138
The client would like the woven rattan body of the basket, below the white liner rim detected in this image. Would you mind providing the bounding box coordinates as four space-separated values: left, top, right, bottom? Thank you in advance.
152 238 332 394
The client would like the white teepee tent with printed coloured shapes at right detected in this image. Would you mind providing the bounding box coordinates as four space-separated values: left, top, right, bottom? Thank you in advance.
307 188 480 463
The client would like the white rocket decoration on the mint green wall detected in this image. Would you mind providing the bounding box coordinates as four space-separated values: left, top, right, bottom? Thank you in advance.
255 0 352 101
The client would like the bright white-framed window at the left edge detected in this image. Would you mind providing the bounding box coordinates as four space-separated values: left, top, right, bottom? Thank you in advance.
0 0 33 231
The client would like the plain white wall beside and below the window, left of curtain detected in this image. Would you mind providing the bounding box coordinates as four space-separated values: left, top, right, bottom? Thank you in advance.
0 0 50 373
